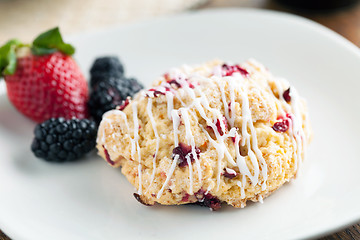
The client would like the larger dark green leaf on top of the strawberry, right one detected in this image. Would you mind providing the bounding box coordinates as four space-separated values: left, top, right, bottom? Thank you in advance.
32 27 75 55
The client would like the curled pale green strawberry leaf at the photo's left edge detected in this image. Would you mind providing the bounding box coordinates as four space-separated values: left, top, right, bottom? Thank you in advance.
0 39 22 77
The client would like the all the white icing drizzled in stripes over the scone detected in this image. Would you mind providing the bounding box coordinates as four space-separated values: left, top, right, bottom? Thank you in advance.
97 60 305 202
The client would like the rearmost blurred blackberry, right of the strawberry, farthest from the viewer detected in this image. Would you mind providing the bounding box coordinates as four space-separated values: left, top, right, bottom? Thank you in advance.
90 56 124 87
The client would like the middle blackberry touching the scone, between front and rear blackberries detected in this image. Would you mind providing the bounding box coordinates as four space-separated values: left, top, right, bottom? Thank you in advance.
88 77 143 124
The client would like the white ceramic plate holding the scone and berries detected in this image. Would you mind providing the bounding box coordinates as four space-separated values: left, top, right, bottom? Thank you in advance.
0 9 360 240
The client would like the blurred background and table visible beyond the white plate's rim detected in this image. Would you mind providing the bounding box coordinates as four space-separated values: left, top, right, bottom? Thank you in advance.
0 0 360 240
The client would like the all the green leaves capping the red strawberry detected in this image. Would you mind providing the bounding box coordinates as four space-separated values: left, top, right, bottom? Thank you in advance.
0 27 75 77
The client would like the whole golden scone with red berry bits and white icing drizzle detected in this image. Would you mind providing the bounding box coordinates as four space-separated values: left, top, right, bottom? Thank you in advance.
97 60 311 210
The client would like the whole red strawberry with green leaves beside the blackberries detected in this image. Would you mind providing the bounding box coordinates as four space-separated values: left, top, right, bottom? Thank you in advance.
0 28 88 123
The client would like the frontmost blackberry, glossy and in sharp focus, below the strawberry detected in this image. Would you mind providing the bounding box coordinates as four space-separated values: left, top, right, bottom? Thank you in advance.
31 118 97 162
